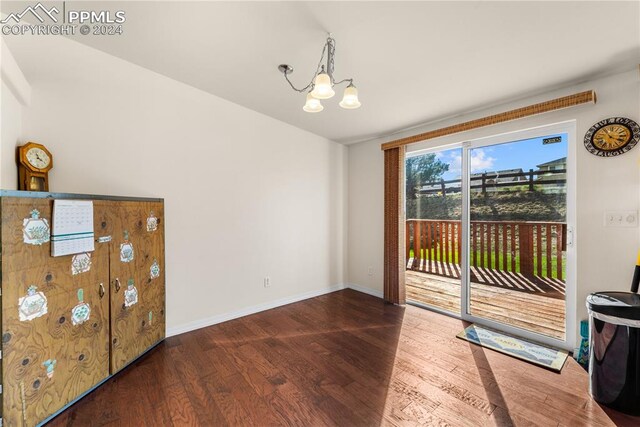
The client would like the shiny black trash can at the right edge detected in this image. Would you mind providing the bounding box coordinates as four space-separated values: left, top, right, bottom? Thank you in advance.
587 292 640 415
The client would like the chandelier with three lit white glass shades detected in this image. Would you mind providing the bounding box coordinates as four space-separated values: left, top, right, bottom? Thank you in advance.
278 34 360 113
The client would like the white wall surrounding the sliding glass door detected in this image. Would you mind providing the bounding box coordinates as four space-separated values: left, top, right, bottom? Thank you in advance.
347 69 640 348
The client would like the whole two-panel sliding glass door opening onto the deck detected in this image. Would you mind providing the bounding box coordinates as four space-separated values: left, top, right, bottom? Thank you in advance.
405 123 575 348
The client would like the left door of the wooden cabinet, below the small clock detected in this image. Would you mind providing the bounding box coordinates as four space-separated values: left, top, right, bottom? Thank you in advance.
2 198 109 426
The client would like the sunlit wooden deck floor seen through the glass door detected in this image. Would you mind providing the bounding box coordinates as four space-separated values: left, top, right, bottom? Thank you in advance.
406 270 565 340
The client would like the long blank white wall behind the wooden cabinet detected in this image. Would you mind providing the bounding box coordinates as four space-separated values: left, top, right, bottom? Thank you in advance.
2 36 347 334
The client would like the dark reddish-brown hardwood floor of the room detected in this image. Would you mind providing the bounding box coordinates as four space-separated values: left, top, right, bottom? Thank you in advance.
49 290 640 426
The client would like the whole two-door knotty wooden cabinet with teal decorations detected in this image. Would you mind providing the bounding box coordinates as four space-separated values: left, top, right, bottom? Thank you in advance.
0 191 165 427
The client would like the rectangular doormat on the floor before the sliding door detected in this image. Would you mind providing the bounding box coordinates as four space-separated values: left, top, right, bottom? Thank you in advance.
456 325 569 372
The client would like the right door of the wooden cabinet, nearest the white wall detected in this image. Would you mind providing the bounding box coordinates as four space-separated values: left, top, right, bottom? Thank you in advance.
111 202 164 373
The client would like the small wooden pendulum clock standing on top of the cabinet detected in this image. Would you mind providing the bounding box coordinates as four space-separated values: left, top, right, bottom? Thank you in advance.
17 142 53 191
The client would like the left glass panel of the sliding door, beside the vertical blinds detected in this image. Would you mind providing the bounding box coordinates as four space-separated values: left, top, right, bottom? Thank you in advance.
405 147 463 314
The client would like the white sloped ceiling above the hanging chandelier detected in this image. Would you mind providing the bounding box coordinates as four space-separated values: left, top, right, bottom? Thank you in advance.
3 1 640 143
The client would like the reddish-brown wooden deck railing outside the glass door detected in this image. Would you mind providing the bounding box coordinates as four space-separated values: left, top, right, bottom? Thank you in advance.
405 219 567 281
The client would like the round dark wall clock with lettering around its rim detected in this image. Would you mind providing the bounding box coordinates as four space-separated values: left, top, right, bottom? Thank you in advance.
584 117 640 157
